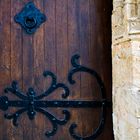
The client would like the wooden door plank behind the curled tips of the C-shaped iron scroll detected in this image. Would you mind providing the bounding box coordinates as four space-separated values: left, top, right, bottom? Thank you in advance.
67 0 82 139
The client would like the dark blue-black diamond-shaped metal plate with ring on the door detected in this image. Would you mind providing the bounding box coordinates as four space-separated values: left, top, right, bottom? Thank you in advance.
14 2 46 34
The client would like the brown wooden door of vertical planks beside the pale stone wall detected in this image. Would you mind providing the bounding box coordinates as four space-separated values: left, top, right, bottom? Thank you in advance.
0 0 113 140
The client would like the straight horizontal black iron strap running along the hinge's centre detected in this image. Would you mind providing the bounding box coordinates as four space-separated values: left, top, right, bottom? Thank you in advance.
6 100 111 108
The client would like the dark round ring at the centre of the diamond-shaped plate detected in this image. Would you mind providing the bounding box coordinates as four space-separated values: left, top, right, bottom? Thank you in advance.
25 17 36 29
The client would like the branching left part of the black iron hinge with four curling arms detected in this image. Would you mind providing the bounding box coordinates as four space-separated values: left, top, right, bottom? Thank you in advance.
0 71 70 137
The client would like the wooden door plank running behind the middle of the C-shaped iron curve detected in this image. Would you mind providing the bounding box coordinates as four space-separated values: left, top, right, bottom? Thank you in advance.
79 0 92 136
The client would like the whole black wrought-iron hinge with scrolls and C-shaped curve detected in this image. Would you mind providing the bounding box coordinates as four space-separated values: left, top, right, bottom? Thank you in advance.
0 55 111 140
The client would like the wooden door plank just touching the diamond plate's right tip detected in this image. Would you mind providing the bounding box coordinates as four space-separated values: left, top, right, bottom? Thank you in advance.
44 0 58 140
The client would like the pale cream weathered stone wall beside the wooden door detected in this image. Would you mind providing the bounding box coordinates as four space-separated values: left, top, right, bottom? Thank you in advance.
112 0 140 140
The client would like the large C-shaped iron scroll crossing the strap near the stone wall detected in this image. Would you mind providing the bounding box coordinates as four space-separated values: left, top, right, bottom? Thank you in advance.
68 54 106 140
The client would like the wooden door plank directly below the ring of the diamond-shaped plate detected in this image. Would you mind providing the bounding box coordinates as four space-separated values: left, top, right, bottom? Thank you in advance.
21 0 34 140
